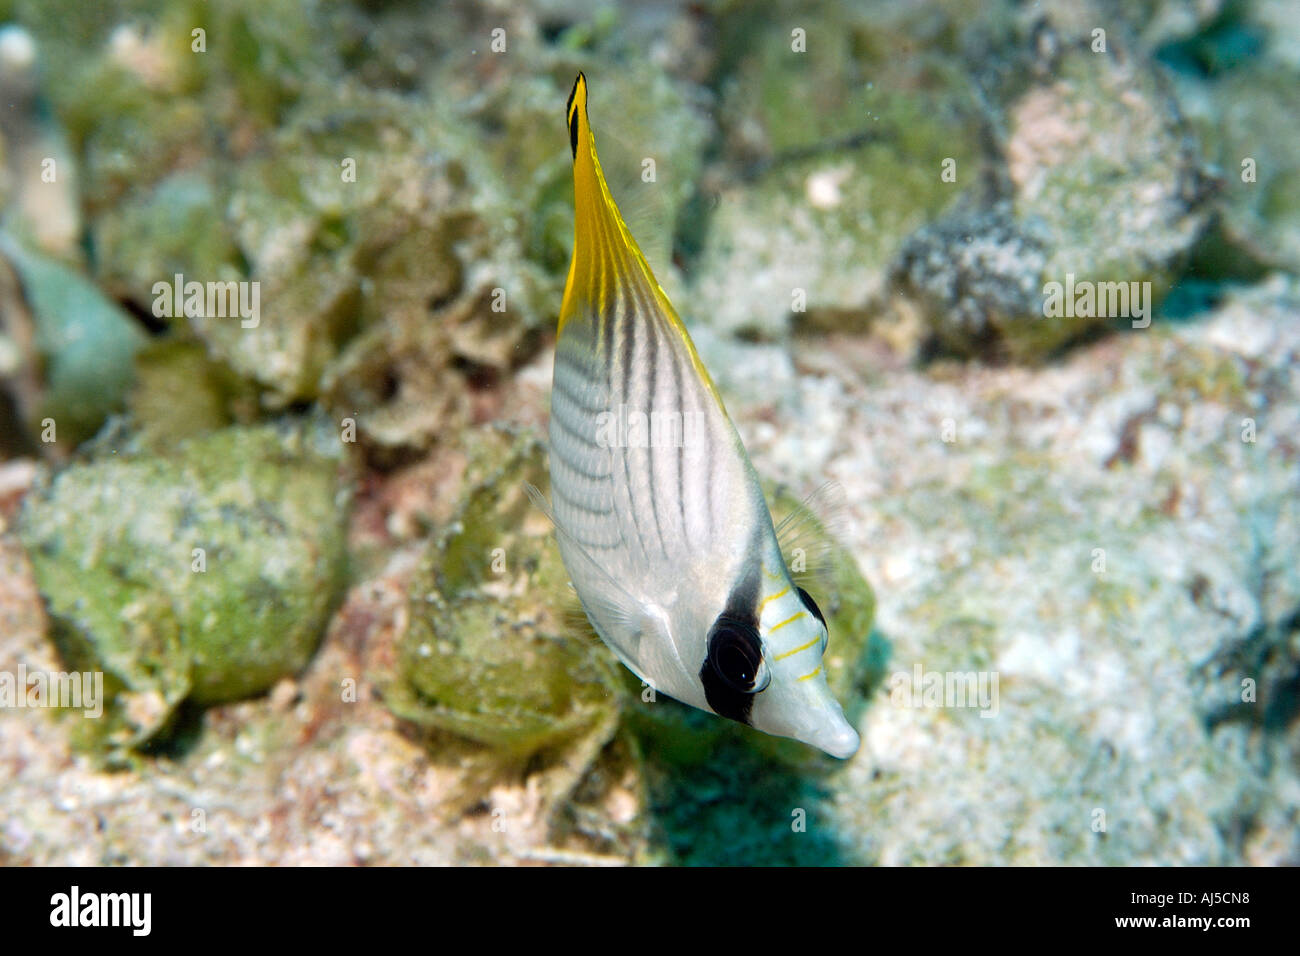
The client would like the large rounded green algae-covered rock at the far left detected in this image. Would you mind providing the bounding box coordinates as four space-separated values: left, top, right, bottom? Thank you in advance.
20 427 347 753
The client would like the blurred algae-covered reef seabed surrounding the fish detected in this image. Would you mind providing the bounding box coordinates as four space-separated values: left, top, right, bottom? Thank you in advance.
0 0 1300 865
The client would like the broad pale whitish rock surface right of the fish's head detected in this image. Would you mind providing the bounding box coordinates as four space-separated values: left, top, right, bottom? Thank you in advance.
754 277 1300 865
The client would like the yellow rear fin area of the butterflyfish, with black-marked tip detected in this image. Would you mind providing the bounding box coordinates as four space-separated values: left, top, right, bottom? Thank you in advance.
559 73 722 405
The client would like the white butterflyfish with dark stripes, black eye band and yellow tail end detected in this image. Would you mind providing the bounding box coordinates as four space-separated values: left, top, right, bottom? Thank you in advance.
530 73 858 758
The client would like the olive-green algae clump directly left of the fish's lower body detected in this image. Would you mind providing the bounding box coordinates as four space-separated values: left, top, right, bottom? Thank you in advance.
384 431 619 764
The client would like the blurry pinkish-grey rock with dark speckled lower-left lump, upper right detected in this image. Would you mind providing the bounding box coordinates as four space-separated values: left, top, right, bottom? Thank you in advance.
892 27 1212 362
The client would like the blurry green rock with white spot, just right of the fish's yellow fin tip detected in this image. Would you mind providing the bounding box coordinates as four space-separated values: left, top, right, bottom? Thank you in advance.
677 10 982 339
